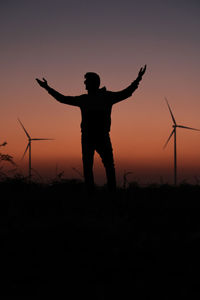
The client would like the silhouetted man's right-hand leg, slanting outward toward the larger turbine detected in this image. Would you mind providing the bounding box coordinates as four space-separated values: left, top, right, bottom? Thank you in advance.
96 134 116 191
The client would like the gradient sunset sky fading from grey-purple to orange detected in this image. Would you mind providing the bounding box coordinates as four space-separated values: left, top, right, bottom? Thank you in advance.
0 0 200 184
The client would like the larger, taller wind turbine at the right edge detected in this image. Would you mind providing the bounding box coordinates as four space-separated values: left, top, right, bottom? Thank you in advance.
163 98 200 185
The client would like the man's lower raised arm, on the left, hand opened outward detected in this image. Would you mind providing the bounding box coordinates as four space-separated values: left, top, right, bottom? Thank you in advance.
36 78 80 106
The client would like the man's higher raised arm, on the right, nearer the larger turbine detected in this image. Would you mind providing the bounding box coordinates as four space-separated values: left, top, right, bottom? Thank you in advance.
110 65 146 104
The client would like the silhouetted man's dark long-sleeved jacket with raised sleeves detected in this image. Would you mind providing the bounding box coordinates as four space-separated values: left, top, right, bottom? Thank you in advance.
47 80 139 135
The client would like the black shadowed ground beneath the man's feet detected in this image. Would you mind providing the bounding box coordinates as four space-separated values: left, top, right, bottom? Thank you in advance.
0 179 200 300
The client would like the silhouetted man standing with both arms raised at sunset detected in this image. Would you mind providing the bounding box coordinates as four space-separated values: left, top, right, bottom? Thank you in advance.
36 65 146 191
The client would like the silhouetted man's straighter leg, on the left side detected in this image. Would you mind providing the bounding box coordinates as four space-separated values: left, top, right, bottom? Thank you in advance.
81 135 94 192
